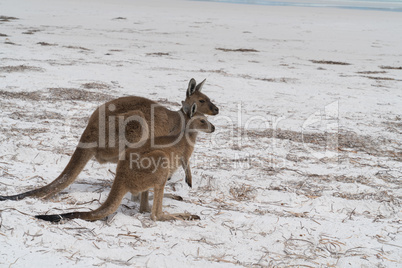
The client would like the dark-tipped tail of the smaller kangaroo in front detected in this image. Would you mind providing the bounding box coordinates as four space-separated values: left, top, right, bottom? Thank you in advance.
35 180 128 222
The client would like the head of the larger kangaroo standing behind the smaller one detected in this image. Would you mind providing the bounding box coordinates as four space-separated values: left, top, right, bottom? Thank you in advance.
184 78 219 115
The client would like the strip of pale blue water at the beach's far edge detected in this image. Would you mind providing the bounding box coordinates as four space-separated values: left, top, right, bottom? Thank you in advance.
192 0 402 12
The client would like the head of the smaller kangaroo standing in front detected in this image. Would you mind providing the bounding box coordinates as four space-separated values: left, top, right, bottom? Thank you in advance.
182 102 215 133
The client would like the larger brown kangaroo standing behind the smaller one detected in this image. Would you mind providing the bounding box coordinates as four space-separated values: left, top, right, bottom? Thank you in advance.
0 78 219 201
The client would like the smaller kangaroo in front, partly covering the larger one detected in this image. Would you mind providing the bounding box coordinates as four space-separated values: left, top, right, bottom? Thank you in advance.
35 104 215 222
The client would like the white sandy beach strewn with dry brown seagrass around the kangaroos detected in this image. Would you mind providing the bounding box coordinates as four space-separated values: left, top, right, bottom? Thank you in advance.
0 0 402 268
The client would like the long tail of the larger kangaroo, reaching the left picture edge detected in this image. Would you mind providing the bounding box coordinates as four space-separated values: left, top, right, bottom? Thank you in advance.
0 148 93 201
